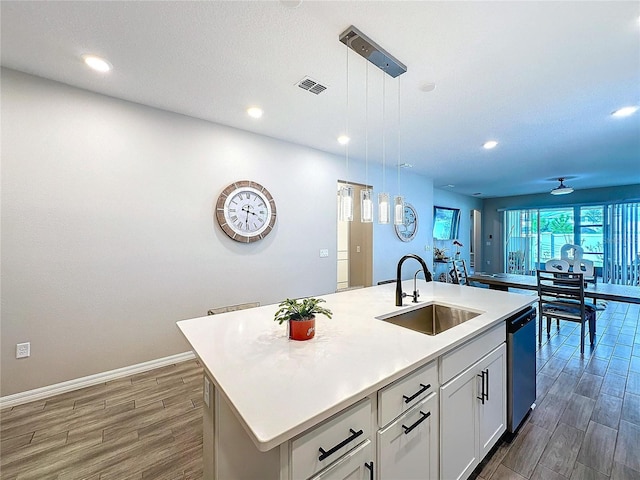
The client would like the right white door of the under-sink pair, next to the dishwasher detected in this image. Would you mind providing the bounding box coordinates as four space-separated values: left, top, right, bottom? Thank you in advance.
478 344 507 459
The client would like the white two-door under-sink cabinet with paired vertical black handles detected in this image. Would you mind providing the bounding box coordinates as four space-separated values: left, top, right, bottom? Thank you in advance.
440 343 507 479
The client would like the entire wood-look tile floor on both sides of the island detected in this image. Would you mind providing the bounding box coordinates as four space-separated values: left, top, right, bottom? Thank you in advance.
0 302 640 480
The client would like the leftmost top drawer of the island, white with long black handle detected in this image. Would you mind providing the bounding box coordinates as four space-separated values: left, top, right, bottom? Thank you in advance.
291 398 371 480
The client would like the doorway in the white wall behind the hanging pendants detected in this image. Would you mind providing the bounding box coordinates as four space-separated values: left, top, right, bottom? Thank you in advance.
336 181 373 291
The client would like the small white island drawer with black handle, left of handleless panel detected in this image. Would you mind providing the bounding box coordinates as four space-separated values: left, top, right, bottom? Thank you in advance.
378 362 438 427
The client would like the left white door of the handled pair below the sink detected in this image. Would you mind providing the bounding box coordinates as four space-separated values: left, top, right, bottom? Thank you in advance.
440 365 481 480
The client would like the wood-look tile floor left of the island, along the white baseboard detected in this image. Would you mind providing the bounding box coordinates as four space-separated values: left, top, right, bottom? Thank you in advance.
0 360 202 480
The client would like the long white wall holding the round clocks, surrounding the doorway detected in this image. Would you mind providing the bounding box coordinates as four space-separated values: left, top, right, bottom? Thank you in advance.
0 69 433 396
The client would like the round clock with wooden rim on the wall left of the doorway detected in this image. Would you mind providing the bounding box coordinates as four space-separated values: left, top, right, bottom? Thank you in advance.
216 180 276 243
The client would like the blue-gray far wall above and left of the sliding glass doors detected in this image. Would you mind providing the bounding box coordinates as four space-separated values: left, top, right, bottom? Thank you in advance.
482 185 640 273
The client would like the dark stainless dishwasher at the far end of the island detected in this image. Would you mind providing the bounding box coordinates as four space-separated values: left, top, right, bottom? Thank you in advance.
507 307 536 441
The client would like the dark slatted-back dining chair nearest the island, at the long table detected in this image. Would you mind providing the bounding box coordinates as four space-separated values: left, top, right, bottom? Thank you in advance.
537 270 596 353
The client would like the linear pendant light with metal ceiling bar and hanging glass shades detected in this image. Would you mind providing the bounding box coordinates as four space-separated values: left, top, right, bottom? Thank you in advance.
339 25 407 224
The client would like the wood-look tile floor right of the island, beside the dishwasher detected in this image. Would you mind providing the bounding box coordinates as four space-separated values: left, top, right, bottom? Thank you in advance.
475 302 640 480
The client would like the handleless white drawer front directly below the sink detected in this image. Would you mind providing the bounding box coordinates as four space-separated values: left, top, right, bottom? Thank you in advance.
440 322 507 384
